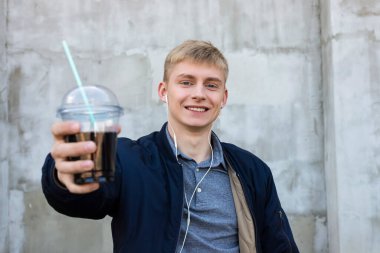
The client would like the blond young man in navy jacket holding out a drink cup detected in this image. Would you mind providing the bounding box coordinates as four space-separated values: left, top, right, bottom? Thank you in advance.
42 41 298 253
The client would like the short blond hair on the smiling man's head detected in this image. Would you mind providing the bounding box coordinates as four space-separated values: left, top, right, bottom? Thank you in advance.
164 40 228 82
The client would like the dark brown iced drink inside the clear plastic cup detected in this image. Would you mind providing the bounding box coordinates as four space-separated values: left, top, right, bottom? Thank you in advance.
65 132 117 184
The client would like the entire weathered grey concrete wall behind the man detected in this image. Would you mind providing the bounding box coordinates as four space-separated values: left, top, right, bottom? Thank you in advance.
0 0 380 253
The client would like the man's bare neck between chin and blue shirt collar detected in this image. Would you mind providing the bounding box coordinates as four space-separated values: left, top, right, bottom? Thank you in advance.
168 123 211 163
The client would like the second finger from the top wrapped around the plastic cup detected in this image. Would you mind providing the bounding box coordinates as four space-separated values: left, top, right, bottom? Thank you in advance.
51 141 96 159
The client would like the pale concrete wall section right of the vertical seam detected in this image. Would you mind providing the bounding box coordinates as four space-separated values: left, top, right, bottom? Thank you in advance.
322 0 380 253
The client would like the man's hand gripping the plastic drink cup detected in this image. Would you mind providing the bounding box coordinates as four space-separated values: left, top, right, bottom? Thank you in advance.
51 121 99 194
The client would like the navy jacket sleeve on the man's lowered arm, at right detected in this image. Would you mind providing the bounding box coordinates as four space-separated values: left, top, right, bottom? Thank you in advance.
262 168 299 253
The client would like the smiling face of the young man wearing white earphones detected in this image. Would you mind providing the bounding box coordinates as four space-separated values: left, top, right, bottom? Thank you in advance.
158 60 228 131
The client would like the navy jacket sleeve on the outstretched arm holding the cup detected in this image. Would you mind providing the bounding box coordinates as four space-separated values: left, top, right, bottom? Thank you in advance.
41 154 120 219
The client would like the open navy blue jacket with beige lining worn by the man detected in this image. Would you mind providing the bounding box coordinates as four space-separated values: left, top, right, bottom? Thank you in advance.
42 124 298 253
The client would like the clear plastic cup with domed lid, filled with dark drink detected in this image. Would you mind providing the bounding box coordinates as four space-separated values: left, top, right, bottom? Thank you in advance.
57 85 123 184
